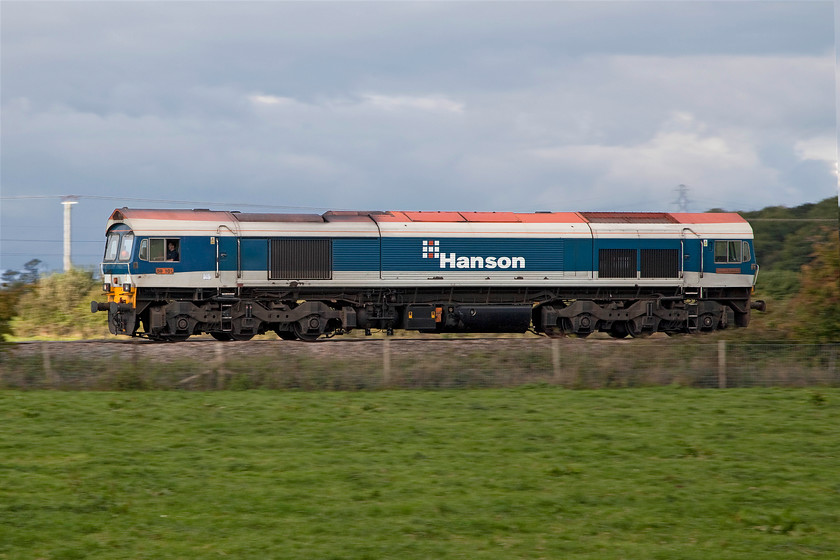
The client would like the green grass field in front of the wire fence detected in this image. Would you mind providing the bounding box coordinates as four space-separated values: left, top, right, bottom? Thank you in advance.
0 387 840 560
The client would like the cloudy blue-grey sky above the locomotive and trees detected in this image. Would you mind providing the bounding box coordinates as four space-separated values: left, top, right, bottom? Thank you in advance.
0 0 838 271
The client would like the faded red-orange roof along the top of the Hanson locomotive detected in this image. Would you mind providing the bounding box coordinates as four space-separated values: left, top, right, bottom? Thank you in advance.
111 208 746 224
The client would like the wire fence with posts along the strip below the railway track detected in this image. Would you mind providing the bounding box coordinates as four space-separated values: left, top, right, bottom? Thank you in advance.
0 338 840 391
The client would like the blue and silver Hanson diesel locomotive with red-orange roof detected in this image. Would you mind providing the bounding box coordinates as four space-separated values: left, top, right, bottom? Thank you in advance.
91 208 763 341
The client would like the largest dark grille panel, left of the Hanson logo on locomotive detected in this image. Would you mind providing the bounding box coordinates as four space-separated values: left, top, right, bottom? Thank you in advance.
268 239 332 280
